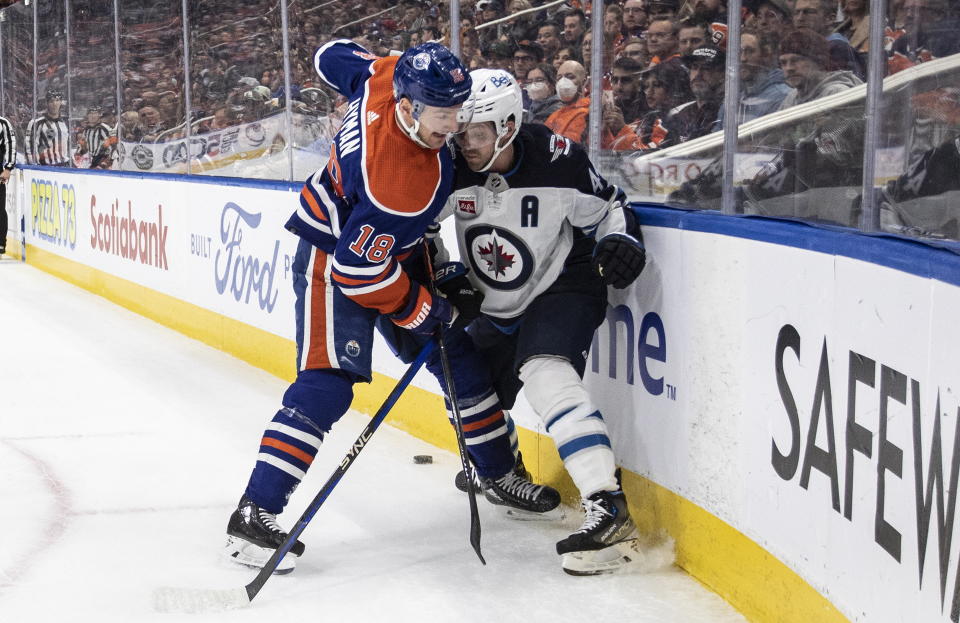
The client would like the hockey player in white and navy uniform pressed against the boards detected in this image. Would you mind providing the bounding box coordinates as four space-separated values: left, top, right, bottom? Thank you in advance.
445 69 646 575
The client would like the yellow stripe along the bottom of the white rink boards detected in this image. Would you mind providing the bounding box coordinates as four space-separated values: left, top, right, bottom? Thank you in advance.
27 245 849 623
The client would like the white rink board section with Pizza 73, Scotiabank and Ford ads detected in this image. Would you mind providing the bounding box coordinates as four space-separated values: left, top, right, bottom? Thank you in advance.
19 170 297 339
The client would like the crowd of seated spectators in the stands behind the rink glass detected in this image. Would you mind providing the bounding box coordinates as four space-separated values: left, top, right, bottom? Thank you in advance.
1 0 960 183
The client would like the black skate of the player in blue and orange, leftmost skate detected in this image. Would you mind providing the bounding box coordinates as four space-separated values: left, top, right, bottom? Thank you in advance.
224 496 305 574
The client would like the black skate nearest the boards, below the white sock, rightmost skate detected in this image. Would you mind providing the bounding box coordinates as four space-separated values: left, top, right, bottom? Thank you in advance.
557 490 639 575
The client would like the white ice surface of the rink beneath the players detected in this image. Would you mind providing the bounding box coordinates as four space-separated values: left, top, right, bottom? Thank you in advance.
0 262 744 623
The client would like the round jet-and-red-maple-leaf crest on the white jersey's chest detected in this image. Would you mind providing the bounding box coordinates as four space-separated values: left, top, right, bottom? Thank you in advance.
464 225 533 290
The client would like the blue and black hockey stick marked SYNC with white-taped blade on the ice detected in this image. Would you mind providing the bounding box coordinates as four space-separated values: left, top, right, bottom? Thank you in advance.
153 340 436 613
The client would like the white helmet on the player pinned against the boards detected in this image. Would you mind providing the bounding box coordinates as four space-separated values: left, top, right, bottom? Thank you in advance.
458 69 523 171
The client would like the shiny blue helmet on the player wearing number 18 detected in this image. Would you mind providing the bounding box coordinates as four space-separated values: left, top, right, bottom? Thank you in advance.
393 43 473 108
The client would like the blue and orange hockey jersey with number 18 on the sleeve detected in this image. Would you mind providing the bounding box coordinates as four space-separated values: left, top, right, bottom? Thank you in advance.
286 40 453 314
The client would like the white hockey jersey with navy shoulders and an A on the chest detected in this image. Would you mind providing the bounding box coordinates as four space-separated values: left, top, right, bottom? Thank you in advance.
443 124 640 320
